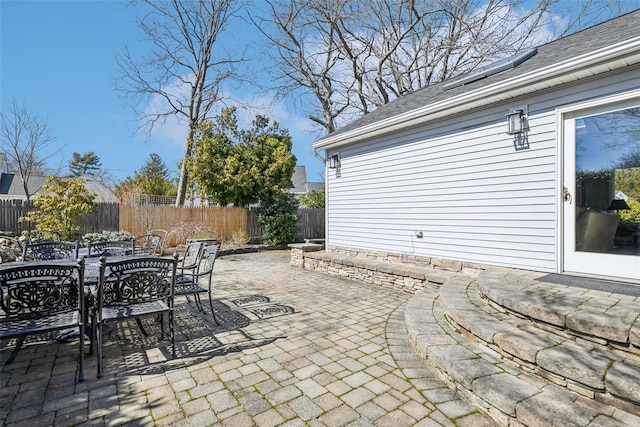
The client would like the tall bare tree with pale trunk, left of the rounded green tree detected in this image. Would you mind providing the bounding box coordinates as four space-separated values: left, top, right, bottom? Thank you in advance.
116 0 242 206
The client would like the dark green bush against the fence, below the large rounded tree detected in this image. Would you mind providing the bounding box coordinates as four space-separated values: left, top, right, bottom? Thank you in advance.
258 191 299 245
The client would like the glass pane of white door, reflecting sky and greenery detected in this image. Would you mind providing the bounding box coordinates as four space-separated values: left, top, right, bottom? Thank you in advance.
575 108 640 255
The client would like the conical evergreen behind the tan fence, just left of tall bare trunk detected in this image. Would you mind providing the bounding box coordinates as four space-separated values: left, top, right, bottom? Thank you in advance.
116 153 177 196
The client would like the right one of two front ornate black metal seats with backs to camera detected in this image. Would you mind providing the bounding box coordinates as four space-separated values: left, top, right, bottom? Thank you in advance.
91 255 178 378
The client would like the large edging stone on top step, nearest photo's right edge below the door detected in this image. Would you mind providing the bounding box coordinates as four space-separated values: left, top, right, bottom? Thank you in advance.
566 309 637 344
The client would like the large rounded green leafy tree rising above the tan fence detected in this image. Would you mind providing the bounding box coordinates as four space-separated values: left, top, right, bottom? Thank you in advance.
188 108 296 206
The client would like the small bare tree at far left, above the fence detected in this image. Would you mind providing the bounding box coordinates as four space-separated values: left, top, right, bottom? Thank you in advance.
0 99 63 200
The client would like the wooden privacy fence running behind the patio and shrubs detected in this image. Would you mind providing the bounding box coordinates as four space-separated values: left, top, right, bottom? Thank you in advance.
0 200 325 244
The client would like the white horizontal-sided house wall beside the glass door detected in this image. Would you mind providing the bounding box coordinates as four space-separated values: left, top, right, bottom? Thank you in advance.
327 67 640 271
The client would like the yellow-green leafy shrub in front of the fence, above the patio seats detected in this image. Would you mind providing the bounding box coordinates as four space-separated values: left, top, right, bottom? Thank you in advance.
19 176 95 240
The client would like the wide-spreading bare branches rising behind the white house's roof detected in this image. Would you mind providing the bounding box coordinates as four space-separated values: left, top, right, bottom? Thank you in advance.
252 0 629 133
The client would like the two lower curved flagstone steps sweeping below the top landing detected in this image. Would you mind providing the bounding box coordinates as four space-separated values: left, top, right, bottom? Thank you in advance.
405 275 640 426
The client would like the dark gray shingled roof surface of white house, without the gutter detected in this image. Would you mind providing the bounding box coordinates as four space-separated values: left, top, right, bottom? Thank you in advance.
328 9 640 137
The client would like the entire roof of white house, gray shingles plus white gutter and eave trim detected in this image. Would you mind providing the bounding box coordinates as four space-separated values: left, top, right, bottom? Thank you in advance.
313 10 640 149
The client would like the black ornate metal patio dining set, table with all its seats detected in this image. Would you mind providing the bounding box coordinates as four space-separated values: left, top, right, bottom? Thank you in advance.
0 237 219 381
